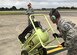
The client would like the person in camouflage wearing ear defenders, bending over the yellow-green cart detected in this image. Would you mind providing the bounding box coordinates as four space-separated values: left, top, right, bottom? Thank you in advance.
49 9 77 55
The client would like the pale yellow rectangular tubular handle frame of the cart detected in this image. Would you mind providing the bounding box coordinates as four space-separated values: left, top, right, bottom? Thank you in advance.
29 14 61 48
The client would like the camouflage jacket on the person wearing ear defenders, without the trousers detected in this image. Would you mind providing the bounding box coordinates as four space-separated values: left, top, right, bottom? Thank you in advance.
57 18 77 48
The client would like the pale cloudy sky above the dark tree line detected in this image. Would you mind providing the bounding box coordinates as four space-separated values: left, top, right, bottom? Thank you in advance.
0 0 77 8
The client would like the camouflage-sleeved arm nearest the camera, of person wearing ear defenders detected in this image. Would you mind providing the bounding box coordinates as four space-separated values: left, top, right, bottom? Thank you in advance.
62 22 75 48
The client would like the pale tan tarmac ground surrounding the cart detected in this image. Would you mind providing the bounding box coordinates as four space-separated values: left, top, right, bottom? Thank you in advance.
0 12 77 55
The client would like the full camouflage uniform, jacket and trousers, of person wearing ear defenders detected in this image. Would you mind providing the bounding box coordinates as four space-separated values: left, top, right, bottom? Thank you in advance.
57 18 77 55
